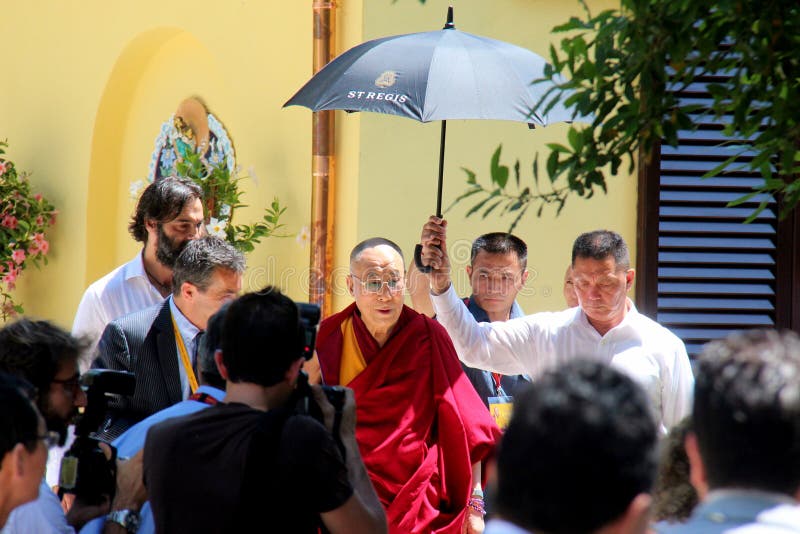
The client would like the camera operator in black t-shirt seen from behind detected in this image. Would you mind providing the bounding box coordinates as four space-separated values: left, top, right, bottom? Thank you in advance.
144 287 386 534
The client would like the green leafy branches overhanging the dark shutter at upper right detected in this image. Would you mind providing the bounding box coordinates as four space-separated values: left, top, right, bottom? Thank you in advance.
456 0 800 227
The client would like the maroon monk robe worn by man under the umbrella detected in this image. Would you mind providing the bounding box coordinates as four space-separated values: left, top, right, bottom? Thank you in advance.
317 304 500 534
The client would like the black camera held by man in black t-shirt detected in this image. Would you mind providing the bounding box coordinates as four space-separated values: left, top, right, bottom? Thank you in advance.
289 302 345 455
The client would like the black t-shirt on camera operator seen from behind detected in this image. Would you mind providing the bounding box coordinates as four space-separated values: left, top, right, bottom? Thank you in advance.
144 404 353 533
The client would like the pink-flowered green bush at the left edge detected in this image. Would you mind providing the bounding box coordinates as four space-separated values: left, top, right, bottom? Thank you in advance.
0 141 57 321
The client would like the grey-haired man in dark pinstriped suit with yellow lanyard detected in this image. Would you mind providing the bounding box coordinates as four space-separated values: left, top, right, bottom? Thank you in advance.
92 236 244 440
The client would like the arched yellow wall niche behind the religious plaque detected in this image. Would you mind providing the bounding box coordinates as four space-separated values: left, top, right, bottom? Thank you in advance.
85 28 230 285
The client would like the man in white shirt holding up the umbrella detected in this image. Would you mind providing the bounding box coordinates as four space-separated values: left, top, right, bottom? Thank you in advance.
421 217 694 434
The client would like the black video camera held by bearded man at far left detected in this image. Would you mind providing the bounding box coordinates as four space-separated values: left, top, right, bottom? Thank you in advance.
58 369 136 504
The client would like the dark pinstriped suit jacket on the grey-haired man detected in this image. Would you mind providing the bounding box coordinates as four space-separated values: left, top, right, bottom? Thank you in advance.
92 299 183 441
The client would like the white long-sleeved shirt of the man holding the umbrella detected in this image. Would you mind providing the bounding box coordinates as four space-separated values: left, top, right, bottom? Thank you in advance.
431 285 694 434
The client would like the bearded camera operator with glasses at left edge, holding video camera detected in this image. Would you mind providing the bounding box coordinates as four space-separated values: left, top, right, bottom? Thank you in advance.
0 319 141 534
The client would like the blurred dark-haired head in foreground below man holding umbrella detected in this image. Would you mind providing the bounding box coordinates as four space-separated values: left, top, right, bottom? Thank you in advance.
495 360 656 534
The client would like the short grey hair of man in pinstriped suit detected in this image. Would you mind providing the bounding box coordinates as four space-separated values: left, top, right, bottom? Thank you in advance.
172 235 244 296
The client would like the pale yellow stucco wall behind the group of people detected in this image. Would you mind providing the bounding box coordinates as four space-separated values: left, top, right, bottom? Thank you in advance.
0 0 635 327
